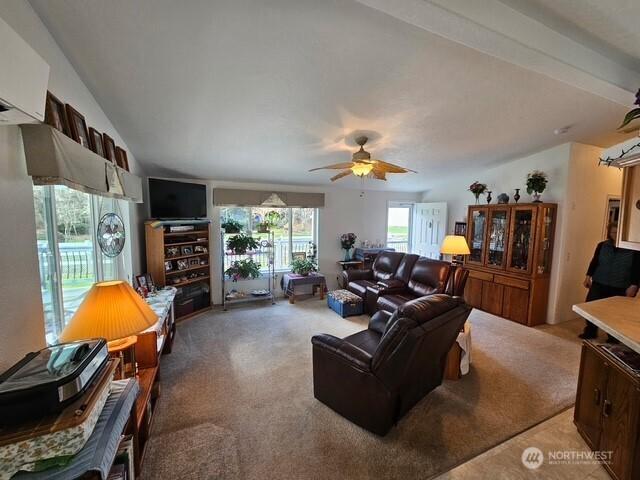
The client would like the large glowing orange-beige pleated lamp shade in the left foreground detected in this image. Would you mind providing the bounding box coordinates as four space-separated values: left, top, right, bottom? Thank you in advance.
60 280 158 342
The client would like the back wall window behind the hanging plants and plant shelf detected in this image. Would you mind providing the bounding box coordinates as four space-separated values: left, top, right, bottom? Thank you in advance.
220 207 317 271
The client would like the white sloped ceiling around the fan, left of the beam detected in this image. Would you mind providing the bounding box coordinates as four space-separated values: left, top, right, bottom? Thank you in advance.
31 0 637 191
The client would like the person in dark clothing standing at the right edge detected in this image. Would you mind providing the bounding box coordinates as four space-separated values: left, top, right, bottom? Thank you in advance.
579 224 640 340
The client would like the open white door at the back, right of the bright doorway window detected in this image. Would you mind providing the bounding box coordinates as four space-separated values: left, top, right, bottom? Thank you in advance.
411 202 447 259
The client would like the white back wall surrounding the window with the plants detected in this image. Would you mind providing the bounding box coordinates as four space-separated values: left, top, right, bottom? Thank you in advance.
145 178 421 303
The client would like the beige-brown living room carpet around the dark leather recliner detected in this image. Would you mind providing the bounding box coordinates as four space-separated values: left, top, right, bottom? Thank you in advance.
143 299 580 480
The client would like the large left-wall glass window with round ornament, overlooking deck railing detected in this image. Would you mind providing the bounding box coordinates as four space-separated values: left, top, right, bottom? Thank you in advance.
33 185 128 344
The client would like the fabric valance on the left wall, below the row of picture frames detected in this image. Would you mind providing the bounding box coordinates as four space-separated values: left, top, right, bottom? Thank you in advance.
20 124 143 203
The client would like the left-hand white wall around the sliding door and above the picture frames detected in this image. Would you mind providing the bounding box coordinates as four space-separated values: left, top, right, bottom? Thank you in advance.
0 0 142 371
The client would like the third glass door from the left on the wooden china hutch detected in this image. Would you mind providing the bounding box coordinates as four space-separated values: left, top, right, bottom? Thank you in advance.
507 207 536 273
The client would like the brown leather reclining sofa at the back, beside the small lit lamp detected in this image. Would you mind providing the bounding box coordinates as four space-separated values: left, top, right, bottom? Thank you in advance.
342 252 458 315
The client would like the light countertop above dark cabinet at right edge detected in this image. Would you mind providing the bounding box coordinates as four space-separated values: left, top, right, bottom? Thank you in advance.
573 296 640 353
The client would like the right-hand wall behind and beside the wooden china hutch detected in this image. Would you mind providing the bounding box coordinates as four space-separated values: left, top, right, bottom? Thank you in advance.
423 143 622 323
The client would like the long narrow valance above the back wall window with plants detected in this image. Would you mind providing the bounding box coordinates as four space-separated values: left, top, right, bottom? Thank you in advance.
213 188 324 208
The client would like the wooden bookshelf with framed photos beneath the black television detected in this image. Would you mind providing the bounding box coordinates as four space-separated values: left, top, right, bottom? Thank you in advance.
145 220 211 320
